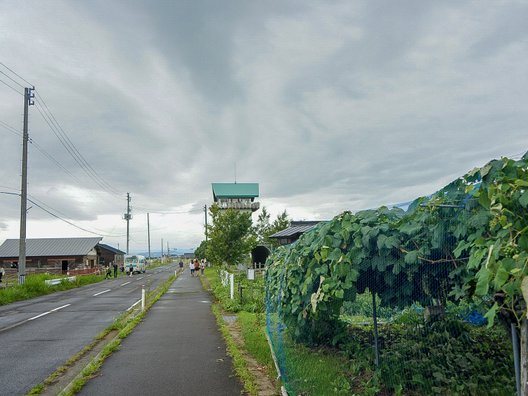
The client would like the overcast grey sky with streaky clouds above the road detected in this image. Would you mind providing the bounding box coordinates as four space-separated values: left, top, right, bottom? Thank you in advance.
0 0 528 251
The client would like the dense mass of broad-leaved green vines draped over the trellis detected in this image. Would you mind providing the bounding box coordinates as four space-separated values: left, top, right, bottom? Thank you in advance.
267 155 528 343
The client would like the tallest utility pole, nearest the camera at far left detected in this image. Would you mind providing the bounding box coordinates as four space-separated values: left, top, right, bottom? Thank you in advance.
18 87 35 285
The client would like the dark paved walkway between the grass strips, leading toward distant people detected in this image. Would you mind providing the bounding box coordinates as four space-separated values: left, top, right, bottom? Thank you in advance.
80 271 242 396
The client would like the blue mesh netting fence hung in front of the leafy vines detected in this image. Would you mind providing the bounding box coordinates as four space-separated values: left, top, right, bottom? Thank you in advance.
266 155 528 395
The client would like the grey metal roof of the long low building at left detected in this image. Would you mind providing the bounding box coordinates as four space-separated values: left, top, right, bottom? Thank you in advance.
0 237 103 257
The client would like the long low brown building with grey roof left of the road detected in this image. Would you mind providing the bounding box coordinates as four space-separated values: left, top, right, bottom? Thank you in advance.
0 237 124 272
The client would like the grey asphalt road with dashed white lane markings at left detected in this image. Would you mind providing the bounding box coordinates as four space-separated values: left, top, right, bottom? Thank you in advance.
0 264 176 395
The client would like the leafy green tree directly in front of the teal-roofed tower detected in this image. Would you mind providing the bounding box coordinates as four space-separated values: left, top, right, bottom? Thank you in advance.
206 205 257 265
